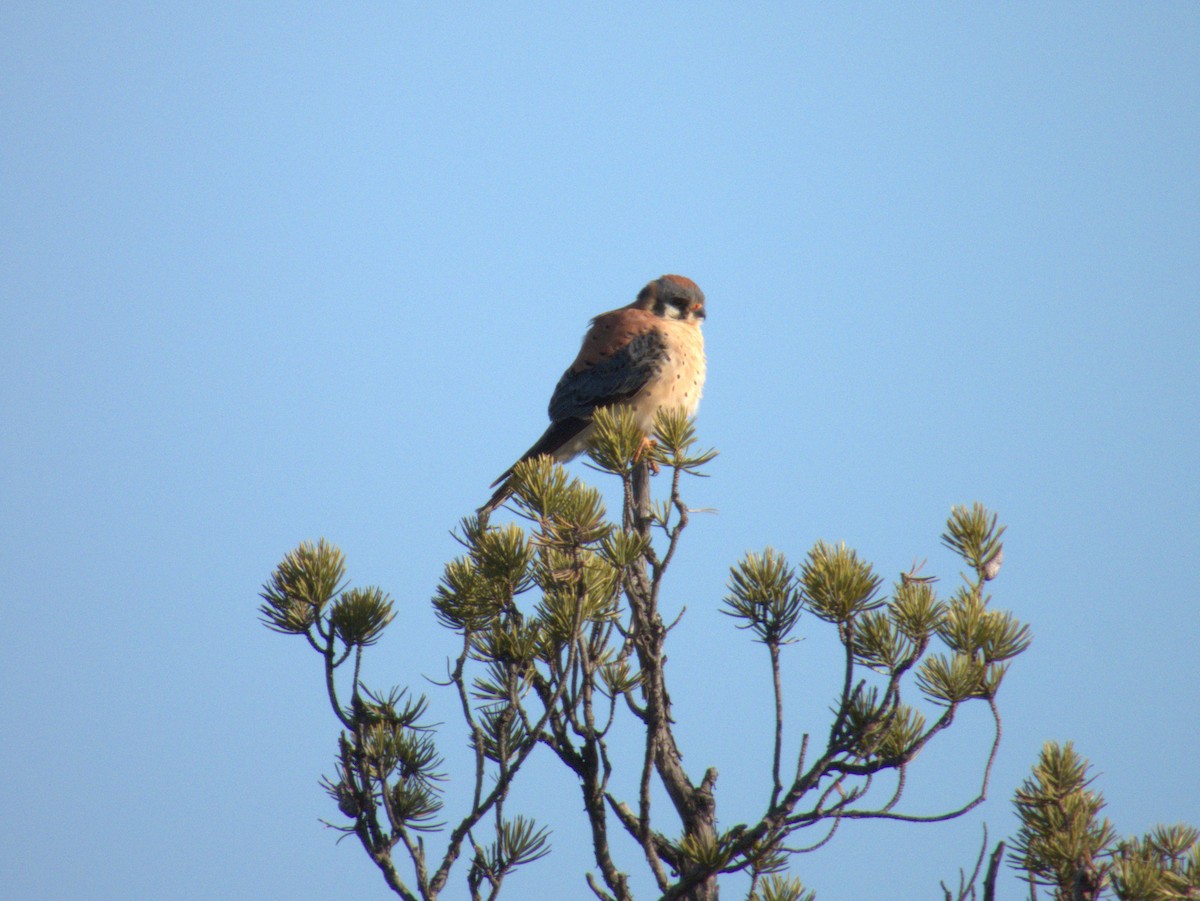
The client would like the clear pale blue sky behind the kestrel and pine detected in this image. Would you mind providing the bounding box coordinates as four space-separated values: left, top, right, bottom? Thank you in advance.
0 2 1200 901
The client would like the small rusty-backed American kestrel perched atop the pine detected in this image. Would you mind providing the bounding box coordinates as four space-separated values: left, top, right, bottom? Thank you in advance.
479 275 704 516
